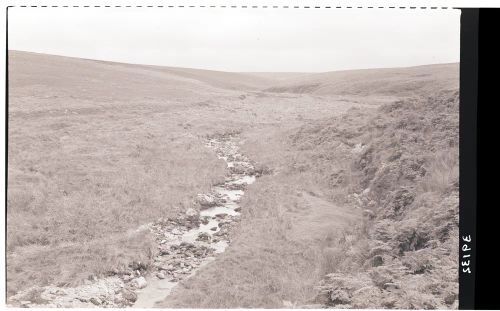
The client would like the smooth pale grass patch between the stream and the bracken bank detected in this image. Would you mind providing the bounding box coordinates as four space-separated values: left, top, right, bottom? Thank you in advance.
161 176 358 308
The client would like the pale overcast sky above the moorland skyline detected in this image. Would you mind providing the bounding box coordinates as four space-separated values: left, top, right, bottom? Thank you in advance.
8 7 460 72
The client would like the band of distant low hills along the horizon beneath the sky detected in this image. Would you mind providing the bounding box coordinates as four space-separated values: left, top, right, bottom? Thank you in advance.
9 51 459 98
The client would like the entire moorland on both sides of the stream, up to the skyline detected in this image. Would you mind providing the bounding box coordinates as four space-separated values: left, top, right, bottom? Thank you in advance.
7 52 458 308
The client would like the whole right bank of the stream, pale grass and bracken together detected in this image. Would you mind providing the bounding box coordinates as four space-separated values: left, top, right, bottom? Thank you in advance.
162 91 458 309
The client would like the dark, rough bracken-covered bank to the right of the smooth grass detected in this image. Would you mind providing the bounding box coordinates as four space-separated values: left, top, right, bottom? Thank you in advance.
291 91 458 309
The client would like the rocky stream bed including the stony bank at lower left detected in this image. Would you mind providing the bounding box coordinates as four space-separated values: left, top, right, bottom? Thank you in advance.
8 135 259 308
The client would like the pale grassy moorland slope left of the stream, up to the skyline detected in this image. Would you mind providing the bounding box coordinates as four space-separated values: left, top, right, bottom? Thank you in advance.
7 53 230 294
